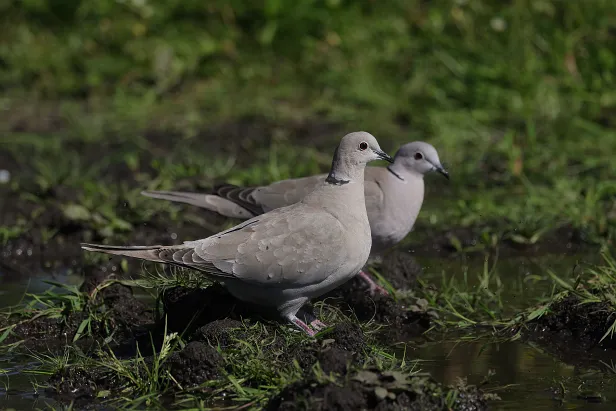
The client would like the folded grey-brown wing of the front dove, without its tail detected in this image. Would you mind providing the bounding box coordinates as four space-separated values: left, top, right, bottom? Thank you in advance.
187 204 348 287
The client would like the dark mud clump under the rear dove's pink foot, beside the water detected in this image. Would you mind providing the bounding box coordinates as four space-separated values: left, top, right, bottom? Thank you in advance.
322 276 433 343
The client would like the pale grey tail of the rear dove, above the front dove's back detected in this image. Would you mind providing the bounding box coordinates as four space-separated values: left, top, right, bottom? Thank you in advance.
141 191 256 220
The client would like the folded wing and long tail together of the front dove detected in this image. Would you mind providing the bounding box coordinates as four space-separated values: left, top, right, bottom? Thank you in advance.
82 208 349 287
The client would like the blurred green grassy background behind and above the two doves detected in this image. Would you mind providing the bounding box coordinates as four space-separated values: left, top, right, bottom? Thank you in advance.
0 0 616 243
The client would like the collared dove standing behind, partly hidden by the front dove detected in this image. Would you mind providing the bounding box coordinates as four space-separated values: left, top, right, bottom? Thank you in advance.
142 141 449 294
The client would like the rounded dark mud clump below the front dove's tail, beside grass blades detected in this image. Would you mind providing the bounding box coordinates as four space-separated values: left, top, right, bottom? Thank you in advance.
165 341 224 388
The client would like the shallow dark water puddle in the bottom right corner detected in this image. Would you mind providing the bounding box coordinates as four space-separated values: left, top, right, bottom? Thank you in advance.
414 339 616 411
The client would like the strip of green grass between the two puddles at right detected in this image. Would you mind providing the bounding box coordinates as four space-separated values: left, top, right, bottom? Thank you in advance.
414 249 616 343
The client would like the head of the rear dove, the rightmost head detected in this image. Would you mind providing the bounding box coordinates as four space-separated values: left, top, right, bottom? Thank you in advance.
391 141 449 179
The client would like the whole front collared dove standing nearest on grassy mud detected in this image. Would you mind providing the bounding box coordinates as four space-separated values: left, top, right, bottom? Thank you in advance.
82 132 393 336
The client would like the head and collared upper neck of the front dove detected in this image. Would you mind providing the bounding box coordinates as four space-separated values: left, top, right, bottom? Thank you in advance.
328 131 393 183
